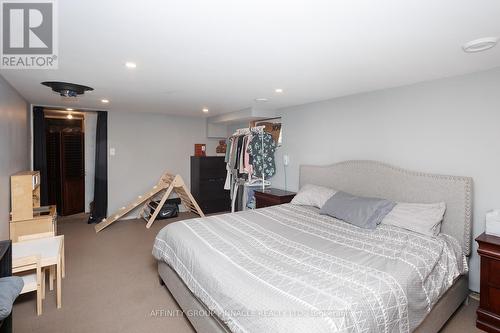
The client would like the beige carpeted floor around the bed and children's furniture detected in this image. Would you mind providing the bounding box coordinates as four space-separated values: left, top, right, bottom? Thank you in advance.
13 213 481 333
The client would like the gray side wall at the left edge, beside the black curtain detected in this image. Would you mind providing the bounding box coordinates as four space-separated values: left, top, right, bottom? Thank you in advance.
0 76 30 239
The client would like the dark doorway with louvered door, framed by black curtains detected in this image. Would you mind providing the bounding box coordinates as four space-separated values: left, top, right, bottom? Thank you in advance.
45 111 85 216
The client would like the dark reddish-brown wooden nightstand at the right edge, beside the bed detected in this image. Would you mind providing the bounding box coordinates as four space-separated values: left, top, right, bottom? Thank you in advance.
476 233 500 332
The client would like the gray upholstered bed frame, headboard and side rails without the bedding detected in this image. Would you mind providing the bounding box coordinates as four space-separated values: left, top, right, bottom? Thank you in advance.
158 161 472 333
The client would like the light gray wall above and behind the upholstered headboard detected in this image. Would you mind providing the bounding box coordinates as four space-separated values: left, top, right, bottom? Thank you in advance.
273 69 500 291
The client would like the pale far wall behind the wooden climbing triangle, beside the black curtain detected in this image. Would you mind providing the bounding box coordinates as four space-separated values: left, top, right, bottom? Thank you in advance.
108 112 218 214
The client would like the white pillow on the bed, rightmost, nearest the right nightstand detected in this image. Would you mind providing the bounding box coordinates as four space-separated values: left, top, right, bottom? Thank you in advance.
382 202 446 236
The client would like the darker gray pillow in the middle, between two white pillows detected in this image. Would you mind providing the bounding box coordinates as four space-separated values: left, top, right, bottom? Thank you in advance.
319 191 396 229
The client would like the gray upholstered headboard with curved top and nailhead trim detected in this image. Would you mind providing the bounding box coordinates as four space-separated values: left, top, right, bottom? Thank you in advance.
300 161 472 255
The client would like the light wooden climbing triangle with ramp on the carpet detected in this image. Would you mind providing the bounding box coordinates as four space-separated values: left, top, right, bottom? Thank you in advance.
94 172 205 233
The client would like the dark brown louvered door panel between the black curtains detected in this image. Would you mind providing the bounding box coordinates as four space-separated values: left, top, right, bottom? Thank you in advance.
61 133 85 215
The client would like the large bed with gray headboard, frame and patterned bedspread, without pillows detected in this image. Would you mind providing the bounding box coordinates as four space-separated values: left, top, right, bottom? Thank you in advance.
153 161 472 333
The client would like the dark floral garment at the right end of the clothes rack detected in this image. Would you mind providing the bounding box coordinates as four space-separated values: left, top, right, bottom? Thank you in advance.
247 133 276 179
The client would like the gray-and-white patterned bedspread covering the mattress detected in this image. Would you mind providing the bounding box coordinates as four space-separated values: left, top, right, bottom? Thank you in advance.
153 204 467 332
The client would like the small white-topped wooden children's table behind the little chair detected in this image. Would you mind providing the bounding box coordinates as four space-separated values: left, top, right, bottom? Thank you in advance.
12 235 64 309
